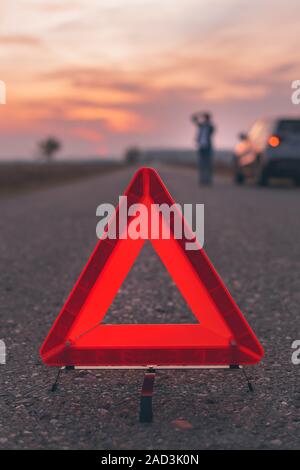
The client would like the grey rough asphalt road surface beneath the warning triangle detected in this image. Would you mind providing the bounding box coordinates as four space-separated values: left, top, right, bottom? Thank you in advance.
0 167 300 449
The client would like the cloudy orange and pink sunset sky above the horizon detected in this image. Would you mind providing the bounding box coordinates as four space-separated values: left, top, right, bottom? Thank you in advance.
0 0 300 158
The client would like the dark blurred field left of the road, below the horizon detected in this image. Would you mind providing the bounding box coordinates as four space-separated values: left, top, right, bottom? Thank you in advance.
0 161 123 196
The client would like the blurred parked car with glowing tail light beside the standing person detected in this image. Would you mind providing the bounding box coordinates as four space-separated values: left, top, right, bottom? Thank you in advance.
233 118 300 186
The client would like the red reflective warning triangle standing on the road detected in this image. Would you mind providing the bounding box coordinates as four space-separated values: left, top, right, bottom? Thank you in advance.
41 168 263 367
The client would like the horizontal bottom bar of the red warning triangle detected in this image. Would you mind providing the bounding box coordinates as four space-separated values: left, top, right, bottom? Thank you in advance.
44 324 257 367
